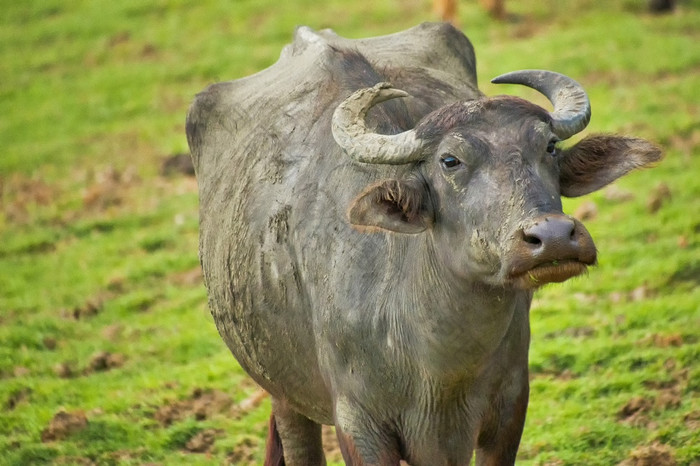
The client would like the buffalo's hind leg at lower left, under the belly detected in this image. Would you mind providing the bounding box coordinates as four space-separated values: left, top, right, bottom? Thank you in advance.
265 397 326 466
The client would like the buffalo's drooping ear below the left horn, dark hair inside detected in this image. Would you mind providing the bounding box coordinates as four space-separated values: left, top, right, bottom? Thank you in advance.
348 180 433 234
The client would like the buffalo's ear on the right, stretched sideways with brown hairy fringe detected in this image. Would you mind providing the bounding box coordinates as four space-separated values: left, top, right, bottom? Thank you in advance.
559 134 662 197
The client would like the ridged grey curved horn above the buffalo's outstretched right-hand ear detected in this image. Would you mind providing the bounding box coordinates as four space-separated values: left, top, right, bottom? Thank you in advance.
491 70 591 139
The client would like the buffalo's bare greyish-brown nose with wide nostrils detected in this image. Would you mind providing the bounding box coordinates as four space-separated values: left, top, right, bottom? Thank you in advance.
522 215 595 263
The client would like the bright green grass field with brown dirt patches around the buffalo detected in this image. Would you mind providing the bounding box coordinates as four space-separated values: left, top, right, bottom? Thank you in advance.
0 0 700 465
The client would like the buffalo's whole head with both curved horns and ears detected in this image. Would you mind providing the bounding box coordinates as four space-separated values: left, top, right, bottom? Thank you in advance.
333 70 661 288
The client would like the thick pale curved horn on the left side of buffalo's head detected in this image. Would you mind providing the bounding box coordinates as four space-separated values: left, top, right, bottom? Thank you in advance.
331 83 423 165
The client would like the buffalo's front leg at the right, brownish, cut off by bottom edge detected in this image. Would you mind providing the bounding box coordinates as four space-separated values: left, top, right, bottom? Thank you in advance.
476 381 530 466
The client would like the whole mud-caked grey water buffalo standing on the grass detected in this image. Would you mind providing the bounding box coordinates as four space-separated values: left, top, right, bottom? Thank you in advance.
187 24 660 466
